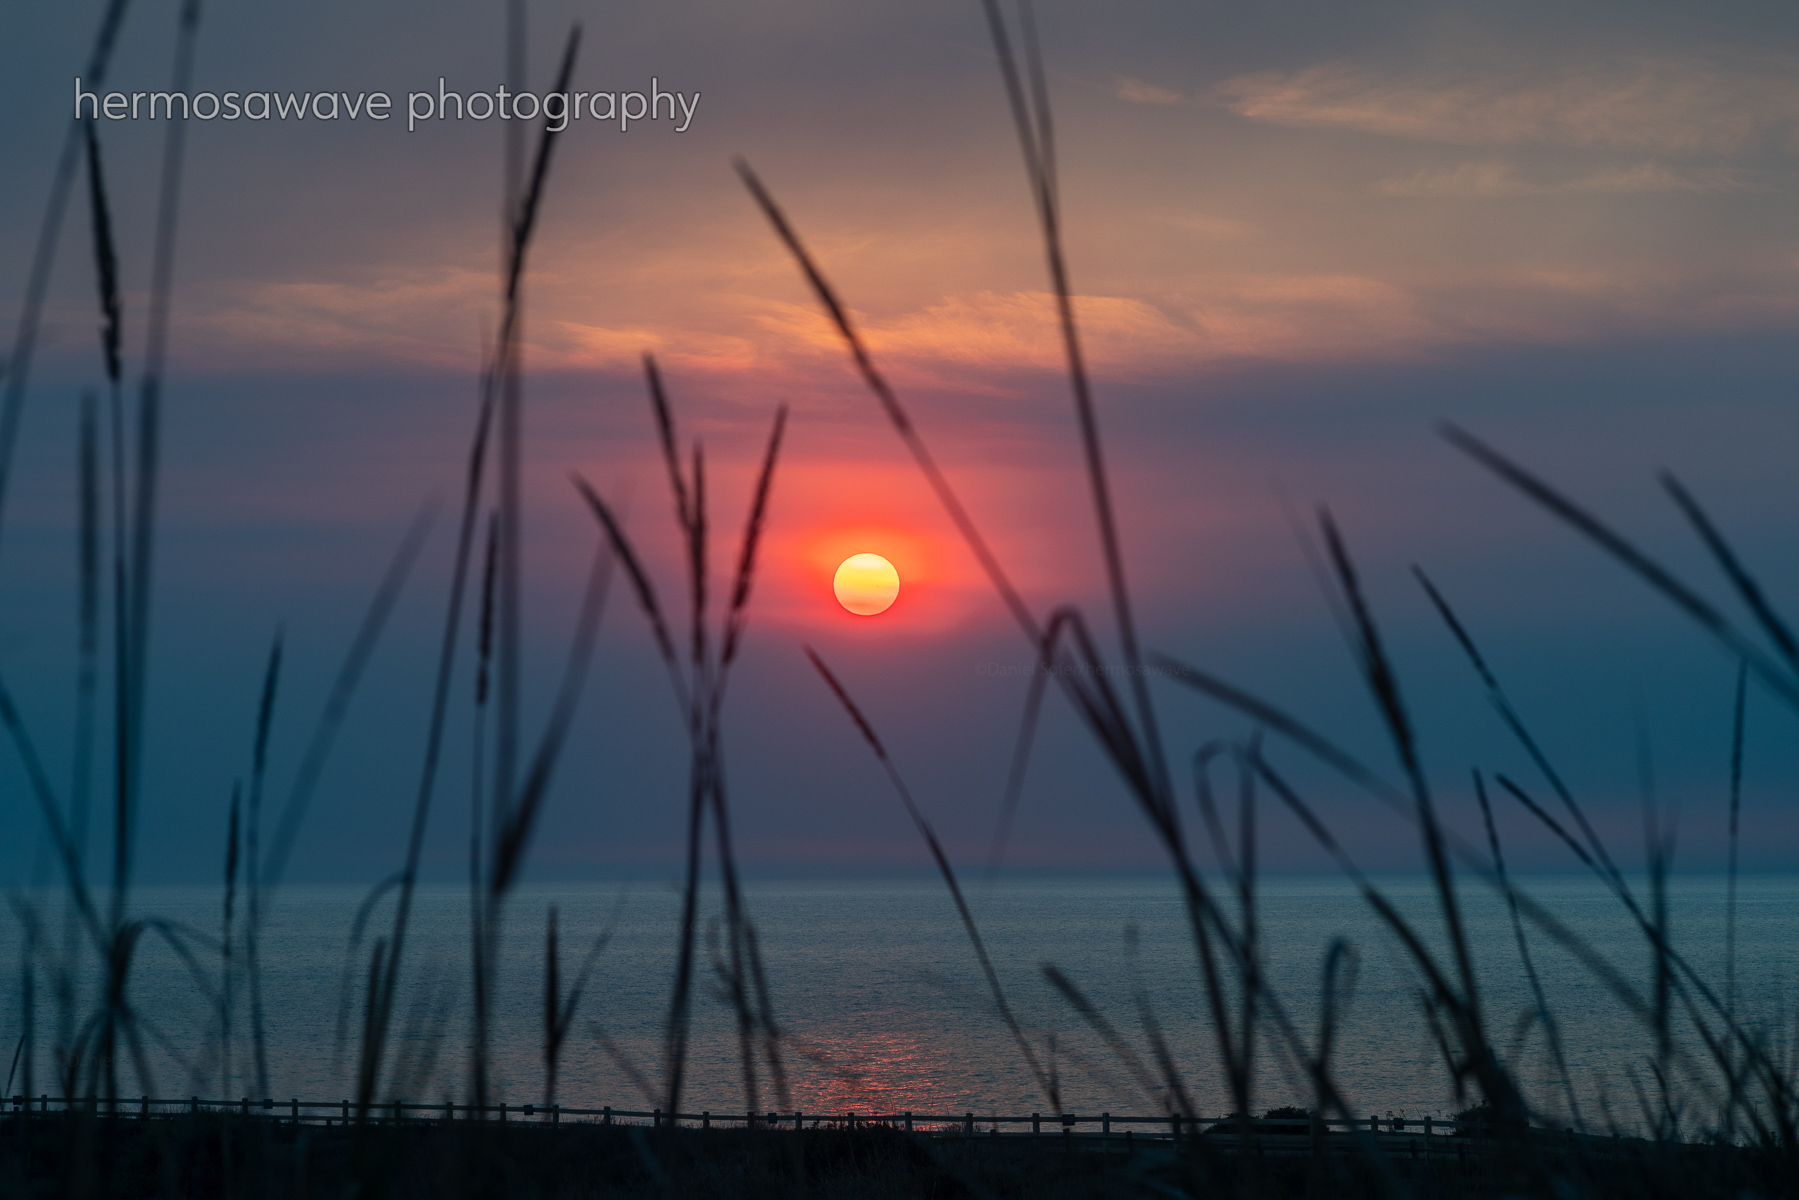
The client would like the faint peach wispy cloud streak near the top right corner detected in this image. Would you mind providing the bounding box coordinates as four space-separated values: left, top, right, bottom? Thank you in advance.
1218 58 1799 155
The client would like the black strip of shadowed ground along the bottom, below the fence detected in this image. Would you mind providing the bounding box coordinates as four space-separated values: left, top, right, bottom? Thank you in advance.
0 1114 1794 1200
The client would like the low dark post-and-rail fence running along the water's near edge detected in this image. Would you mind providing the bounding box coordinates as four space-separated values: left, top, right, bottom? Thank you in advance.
0 1096 1575 1150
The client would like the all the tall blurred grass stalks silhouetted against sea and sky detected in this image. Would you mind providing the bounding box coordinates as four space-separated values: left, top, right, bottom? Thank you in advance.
0 0 1799 1195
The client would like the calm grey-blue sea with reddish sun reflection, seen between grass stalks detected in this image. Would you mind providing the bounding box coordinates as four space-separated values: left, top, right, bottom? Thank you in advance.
0 876 1799 1121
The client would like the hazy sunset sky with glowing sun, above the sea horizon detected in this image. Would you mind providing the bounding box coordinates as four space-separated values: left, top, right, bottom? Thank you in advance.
0 0 1799 882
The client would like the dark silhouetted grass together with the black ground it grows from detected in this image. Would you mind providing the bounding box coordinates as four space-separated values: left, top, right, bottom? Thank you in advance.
10 0 1799 1200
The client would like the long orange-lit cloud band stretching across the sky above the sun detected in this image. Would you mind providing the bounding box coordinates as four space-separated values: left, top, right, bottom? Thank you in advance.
182 266 1799 379
